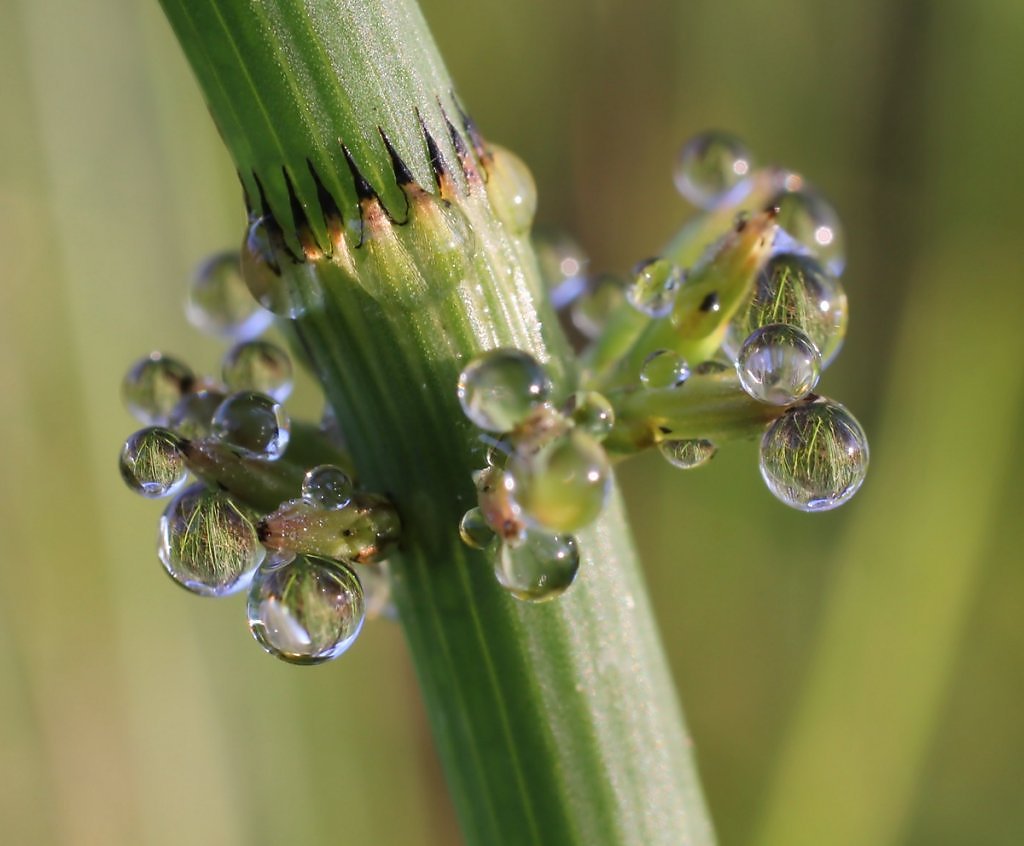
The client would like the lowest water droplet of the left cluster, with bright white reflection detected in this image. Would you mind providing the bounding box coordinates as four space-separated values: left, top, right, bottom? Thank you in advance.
248 553 366 665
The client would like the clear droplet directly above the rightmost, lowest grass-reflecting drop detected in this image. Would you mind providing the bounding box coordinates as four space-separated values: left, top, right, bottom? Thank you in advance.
736 324 821 406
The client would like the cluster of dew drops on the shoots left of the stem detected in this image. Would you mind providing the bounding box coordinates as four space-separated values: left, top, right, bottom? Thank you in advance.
120 252 398 665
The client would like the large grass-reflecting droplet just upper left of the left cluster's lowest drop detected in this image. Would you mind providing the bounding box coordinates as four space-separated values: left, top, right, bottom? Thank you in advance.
158 484 264 596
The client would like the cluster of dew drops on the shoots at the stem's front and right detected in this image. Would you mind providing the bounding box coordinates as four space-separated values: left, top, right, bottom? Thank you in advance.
458 132 868 601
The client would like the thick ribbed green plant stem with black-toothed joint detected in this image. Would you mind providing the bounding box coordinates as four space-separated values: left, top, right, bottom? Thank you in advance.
163 0 713 846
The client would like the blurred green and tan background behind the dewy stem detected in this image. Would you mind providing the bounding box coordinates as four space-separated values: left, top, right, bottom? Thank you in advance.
0 0 1024 846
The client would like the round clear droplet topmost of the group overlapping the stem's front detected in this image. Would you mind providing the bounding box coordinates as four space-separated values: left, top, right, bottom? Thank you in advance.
459 349 551 432
